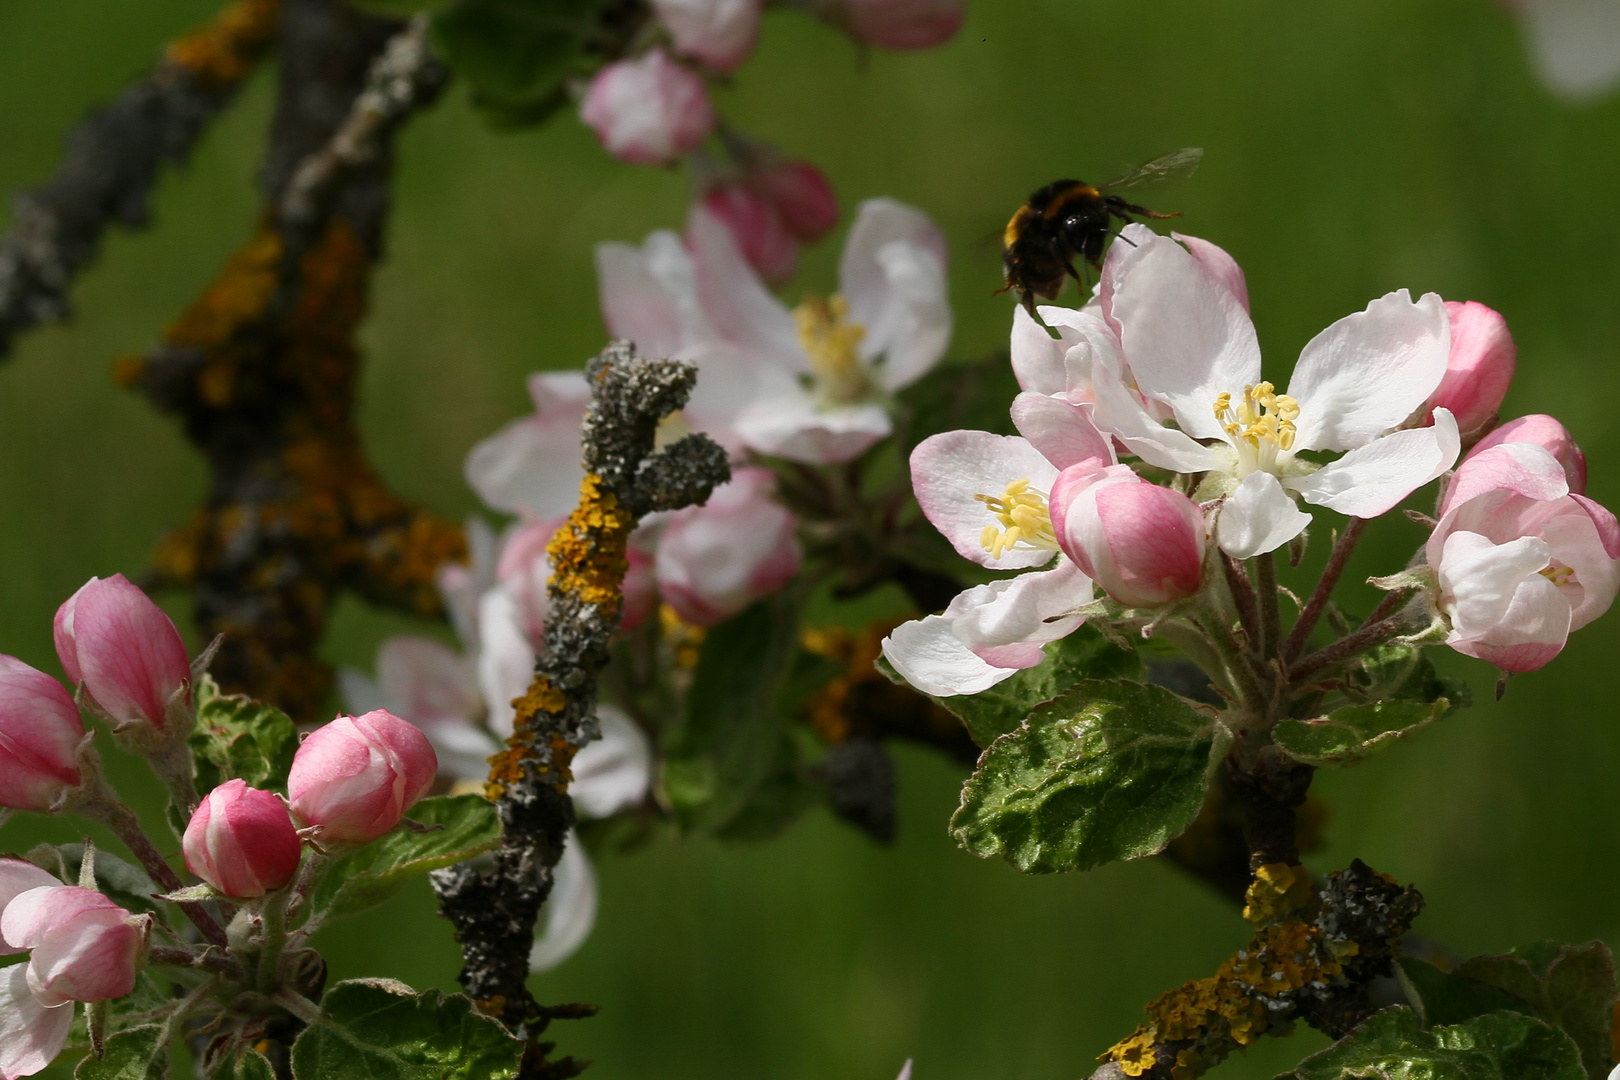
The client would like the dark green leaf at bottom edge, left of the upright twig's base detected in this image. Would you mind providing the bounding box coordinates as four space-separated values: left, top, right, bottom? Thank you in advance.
292 980 523 1080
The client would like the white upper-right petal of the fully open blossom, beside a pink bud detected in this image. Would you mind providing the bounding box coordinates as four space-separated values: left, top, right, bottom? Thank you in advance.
1288 288 1452 450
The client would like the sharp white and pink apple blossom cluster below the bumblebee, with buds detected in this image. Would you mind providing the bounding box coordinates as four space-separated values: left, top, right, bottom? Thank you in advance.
885 225 1620 696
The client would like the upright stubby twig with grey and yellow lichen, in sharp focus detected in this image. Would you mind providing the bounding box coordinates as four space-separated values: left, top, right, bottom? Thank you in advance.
433 342 731 1077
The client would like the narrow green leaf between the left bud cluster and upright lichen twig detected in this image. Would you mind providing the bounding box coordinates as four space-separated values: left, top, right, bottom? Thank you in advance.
309 795 501 923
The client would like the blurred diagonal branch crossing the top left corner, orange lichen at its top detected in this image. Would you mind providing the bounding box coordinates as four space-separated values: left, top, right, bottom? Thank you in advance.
0 0 280 356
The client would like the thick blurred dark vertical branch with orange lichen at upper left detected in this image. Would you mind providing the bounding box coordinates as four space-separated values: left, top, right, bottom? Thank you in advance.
117 0 465 719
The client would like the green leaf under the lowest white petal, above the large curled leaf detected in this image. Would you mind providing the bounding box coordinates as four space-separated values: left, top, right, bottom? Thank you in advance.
878 625 1144 746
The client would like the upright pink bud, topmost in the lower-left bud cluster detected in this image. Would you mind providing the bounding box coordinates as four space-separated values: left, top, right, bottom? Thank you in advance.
55 573 191 727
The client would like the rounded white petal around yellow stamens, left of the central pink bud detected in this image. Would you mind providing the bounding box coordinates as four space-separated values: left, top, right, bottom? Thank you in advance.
910 431 1058 570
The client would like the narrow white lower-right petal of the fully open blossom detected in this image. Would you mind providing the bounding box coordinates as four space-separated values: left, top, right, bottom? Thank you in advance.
1288 408 1461 518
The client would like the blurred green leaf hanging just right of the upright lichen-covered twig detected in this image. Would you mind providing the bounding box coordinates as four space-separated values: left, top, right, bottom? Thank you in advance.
663 594 799 832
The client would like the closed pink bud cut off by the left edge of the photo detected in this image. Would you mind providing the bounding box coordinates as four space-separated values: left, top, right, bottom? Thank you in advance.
0 656 84 810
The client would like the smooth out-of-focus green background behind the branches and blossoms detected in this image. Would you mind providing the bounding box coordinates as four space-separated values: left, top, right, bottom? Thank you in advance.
0 0 1620 1080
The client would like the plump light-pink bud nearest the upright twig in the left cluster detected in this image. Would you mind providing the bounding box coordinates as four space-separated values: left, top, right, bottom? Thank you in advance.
287 709 439 844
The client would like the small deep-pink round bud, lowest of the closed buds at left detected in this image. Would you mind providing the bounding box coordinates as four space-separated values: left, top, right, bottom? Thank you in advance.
181 780 303 899
